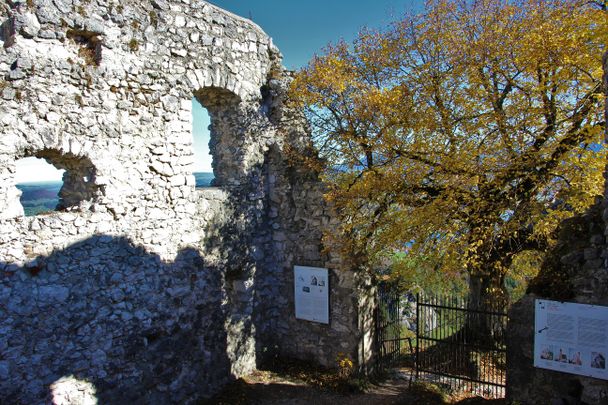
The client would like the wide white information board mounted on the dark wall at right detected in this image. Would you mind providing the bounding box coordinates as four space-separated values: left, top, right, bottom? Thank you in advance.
534 300 608 380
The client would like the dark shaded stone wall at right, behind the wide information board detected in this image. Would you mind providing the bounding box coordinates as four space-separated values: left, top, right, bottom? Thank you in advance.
507 201 608 404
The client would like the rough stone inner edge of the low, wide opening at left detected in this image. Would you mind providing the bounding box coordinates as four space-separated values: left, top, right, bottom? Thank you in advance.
9 148 102 215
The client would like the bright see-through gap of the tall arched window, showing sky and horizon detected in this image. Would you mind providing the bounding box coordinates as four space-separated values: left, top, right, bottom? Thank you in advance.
192 97 214 188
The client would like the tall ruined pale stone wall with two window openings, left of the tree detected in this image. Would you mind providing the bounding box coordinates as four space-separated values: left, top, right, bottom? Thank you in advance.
0 0 370 403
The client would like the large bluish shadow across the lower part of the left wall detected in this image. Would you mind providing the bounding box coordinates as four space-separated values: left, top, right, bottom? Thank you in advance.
0 235 230 404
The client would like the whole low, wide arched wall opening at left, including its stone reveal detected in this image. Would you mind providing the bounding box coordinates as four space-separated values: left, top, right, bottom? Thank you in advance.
15 149 100 216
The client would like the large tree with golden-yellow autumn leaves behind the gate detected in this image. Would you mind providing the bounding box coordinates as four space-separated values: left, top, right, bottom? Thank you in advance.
292 0 608 314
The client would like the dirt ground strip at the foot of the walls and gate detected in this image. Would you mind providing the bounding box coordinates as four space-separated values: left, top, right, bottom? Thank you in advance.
201 362 506 405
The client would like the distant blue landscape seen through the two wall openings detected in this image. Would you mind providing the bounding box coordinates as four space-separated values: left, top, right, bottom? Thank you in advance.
17 173 214 217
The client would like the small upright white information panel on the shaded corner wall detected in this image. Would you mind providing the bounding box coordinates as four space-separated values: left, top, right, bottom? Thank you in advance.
293 266 329 324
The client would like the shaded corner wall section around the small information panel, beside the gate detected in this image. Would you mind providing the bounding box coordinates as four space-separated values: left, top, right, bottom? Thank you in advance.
251 76 375 372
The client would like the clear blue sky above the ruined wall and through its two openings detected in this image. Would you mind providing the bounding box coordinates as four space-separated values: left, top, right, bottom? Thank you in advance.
17 0 424 183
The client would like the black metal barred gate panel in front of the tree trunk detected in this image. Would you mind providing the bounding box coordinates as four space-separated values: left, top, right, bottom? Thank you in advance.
416 296 507 398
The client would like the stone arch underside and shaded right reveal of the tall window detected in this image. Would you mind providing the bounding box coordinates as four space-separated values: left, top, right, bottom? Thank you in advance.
194 87 243 186
